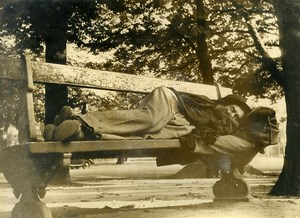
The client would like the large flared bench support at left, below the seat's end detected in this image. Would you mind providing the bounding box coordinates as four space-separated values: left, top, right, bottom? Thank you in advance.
0 146 63 218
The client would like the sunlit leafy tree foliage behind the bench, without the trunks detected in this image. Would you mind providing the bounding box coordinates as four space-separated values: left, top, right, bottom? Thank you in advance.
2 0 282 127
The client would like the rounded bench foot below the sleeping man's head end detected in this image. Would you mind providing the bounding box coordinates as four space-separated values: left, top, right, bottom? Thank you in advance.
213 155 251 202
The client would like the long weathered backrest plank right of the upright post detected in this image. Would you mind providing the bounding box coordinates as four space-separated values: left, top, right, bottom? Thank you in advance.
31 61 232 99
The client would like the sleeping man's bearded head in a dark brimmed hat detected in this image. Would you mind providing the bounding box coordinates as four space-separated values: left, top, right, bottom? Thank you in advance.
216 94 251 121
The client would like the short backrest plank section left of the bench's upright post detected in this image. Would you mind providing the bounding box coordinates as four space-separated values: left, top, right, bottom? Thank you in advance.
0 55 26 80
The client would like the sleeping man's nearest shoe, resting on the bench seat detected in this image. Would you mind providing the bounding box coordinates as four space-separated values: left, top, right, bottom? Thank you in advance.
52 120 81 141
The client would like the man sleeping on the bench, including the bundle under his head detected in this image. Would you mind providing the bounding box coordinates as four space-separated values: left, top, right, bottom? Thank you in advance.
44 87 279 169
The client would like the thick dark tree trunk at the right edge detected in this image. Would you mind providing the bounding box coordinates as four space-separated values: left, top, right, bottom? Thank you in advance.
270 0 300 196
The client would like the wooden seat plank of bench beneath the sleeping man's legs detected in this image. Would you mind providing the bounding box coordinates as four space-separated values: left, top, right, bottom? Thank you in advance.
26 139 181 154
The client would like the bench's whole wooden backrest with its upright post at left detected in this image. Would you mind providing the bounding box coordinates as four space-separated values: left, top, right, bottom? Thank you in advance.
0 55 232 143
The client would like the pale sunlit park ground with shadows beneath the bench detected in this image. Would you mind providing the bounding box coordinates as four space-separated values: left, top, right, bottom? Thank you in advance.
0 159 300 218
